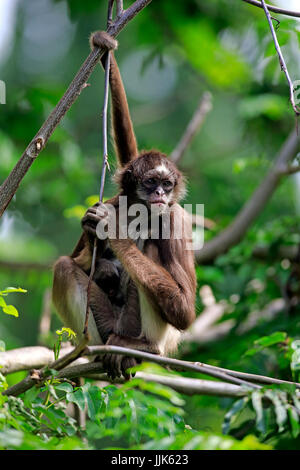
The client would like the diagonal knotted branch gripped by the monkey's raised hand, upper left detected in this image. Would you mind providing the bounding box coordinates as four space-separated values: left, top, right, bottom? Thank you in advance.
0 0 152 217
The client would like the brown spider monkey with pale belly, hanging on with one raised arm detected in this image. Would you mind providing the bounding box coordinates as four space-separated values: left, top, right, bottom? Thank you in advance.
53 31 196 378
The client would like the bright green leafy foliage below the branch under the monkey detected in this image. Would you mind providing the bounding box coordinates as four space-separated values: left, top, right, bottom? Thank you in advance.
0 366 270 450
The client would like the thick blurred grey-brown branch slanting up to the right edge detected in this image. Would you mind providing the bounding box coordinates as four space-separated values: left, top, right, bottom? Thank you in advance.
195 131 299 264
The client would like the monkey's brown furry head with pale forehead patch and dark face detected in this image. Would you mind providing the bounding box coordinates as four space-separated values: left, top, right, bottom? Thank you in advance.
116 150 185 213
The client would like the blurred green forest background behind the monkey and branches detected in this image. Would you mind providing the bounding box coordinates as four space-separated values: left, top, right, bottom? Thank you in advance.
0 0 300 448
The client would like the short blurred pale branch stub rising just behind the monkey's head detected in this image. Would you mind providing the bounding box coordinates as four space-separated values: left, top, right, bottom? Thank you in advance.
170 91 212 163
